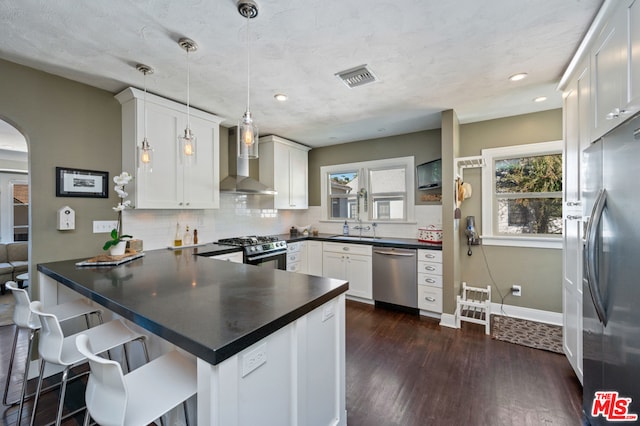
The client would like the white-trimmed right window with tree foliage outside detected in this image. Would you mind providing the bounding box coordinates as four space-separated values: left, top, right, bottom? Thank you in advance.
482 141 563 248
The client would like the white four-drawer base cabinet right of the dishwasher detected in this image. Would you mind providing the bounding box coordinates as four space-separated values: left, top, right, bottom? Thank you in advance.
417 249 442 314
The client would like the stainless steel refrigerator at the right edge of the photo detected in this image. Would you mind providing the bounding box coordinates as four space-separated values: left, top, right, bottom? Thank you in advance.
582 112 640 425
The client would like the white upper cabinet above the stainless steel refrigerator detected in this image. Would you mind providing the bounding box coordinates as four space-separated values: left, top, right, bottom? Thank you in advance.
590 0 640 140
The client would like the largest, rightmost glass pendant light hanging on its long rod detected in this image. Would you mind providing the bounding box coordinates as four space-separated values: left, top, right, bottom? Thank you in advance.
237 0 258 159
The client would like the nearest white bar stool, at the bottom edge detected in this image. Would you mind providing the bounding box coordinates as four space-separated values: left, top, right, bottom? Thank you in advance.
76 333 197 426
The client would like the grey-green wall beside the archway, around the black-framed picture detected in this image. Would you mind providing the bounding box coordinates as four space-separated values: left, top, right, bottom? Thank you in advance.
0 60 122 298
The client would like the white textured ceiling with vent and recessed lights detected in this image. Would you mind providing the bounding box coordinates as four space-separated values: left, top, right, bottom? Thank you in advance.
0 0 602 147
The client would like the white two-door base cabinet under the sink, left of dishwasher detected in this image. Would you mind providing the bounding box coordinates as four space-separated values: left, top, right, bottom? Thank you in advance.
322 243 373 300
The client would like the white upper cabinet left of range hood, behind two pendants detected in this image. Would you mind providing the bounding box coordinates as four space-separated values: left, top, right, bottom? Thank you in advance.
116 88 222 209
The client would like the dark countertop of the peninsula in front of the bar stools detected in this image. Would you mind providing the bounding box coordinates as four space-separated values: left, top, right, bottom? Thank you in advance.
38 245 349 364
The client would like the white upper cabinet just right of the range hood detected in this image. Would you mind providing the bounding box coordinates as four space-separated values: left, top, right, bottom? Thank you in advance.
259 136 311 210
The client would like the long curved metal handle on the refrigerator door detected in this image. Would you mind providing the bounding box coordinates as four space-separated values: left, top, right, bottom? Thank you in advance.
585 188 607 326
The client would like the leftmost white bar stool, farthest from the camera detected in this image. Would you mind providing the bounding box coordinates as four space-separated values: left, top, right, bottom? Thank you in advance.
2 281 102 423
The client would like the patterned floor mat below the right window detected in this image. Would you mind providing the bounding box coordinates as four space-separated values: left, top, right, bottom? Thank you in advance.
491 315 563 353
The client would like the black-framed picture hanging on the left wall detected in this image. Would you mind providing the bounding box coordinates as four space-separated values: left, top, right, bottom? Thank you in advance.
56 167 109 198
